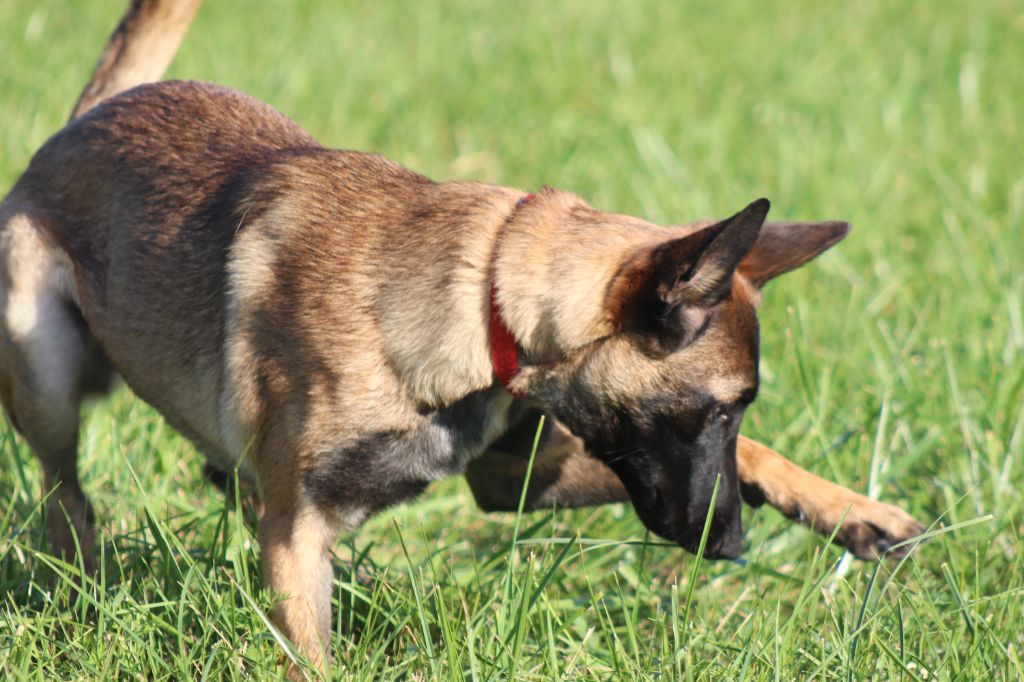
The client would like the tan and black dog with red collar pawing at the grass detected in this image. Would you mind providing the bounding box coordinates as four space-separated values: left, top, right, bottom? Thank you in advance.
0 0 922 665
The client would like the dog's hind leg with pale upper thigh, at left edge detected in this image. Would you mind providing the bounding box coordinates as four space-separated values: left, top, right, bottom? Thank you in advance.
0 204 113 571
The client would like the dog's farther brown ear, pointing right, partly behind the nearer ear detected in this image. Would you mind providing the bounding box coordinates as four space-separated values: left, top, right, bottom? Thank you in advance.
738 220 850 289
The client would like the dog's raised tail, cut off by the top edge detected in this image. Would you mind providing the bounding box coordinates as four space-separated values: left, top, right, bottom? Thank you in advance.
71 0 203 119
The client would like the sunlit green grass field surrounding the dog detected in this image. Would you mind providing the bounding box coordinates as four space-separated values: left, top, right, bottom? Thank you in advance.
0 0 1024 680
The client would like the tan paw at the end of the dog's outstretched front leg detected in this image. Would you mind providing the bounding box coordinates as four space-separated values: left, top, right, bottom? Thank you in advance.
815 496 925 560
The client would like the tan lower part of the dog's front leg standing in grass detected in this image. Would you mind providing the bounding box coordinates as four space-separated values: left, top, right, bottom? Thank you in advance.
259 497 336 678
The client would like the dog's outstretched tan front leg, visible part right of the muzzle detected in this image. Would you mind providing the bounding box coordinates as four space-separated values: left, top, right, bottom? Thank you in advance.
736 436 925 559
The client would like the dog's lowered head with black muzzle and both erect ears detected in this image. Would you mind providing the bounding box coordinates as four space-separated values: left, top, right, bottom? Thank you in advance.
520 200 849 558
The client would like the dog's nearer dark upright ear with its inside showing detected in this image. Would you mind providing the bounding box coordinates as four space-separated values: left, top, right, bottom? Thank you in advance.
609 199 770 353
